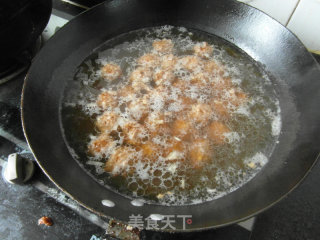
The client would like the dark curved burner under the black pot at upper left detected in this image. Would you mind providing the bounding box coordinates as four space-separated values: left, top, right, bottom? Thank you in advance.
0 36 42 84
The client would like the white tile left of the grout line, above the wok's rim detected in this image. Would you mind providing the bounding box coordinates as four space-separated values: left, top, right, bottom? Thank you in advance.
236 0 299 25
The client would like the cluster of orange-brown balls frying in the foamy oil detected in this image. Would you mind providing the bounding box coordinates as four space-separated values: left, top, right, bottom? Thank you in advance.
88 39 247 176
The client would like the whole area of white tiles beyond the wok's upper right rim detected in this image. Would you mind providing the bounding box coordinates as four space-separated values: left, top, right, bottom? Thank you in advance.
238 0 320 51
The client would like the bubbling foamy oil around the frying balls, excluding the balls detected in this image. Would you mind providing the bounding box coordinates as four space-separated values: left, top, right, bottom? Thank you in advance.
62 26 281 205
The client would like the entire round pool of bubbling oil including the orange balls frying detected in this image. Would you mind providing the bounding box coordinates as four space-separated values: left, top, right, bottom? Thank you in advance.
62 26 281 205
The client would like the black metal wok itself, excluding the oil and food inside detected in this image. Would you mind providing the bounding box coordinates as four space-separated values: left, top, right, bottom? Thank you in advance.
22 0 320 230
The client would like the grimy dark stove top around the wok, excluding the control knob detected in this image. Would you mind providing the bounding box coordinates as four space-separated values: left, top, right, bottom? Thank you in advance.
0 0 320 240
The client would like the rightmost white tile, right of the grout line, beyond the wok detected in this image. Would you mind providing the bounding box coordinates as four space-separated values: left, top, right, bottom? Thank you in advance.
287 0 320 50
